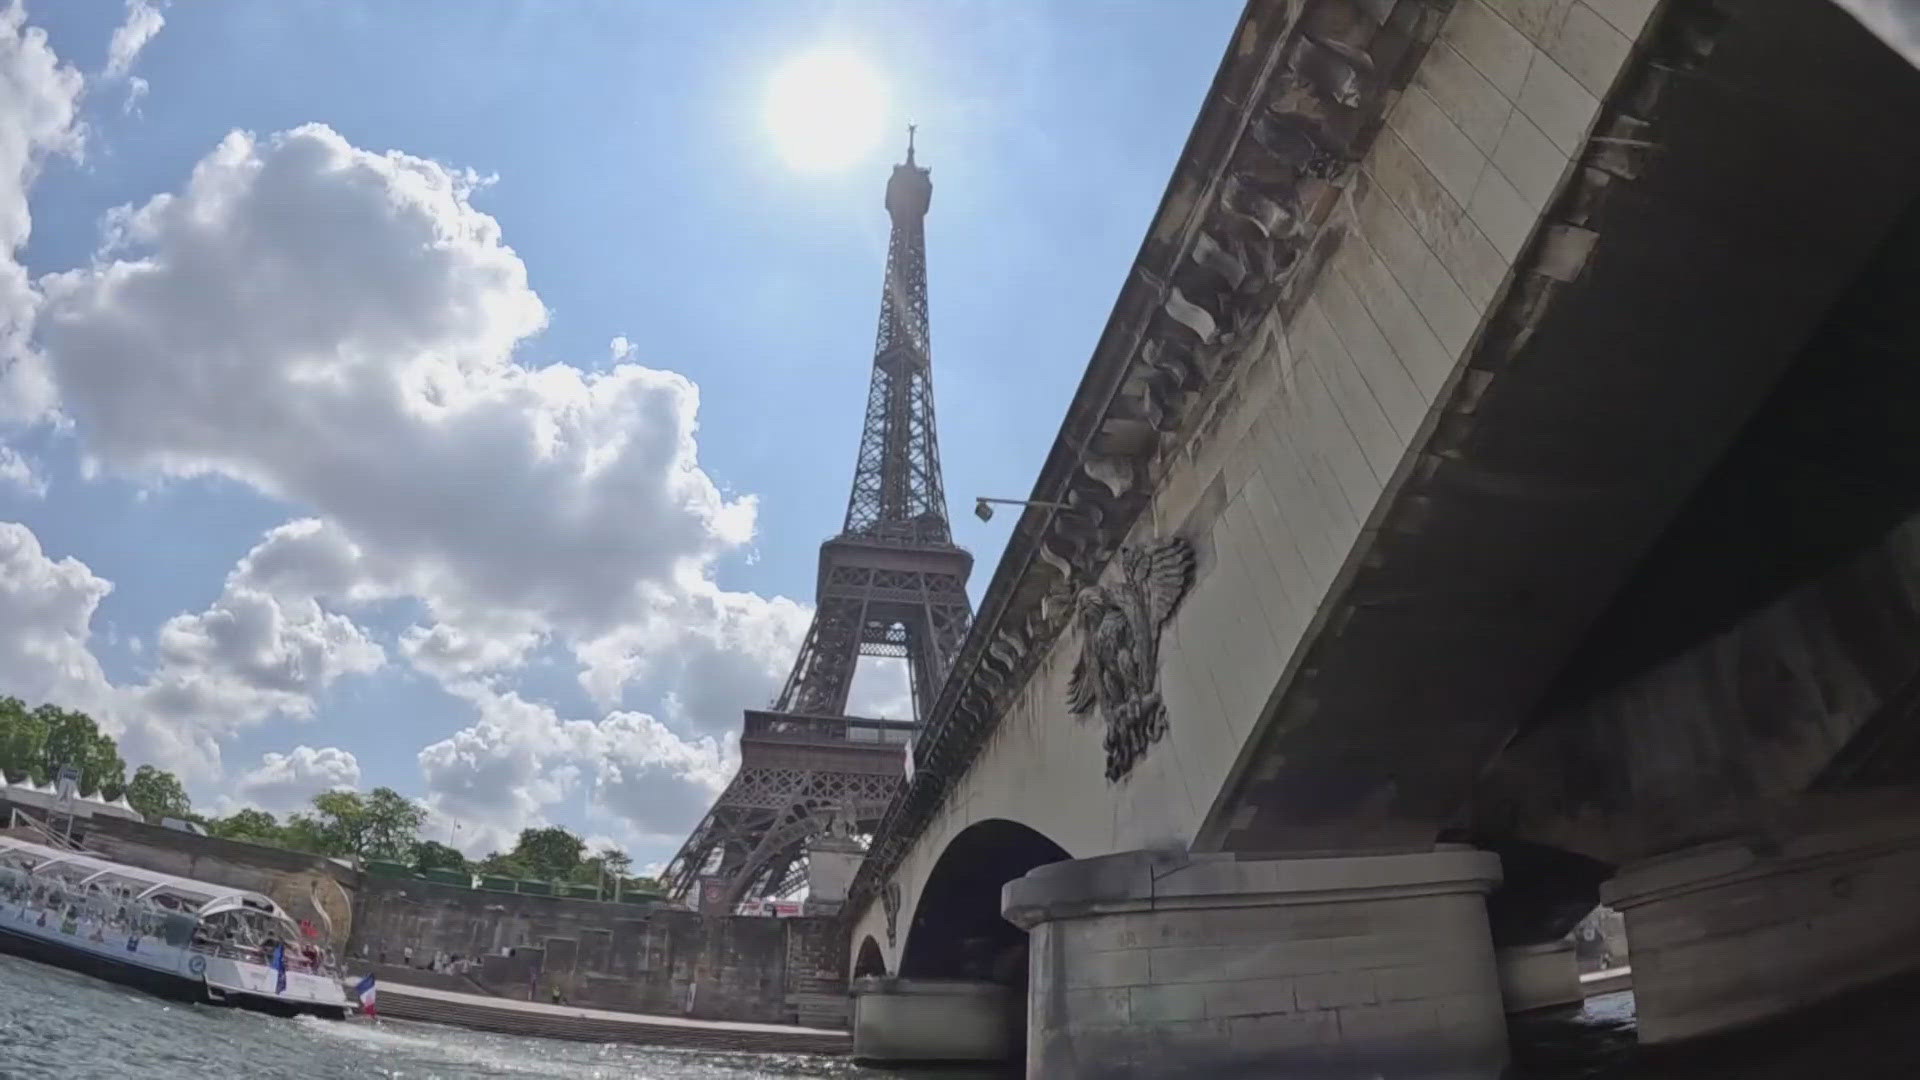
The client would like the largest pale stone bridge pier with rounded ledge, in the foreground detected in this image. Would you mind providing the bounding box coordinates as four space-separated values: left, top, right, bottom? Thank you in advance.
1002 846 1507 1080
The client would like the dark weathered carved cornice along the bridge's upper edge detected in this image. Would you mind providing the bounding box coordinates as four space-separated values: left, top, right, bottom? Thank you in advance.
847 0 1452 917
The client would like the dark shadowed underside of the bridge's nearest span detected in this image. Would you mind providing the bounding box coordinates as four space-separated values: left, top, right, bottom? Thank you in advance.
1196 2 1920 860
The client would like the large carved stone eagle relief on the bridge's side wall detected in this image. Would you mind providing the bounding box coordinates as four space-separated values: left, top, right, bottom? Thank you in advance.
1068 536 1194 782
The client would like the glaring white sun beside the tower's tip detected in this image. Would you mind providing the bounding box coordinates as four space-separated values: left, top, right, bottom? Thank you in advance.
766 50 887 173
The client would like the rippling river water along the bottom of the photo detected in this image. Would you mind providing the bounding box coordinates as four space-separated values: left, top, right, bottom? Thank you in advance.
0 955 1920 1080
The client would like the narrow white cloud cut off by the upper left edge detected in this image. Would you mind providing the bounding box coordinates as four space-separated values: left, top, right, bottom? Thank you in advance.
0 0 84 421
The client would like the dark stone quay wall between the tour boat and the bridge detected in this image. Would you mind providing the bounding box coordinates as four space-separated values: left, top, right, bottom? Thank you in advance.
348 878 847 1026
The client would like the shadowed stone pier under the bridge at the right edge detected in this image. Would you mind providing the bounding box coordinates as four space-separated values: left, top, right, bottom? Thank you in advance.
1601 809 1920 1043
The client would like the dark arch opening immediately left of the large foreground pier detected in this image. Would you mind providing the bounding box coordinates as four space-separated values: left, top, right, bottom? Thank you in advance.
900 817 1071 988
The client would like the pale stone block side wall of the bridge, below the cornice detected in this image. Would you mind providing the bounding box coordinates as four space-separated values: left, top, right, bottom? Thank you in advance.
852 0 1651 970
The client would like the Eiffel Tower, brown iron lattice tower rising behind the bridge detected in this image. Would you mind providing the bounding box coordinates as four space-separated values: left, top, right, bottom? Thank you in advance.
662 127 973 913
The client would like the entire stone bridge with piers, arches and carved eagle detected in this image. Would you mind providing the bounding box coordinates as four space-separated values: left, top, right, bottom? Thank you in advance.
849 0 1920 1078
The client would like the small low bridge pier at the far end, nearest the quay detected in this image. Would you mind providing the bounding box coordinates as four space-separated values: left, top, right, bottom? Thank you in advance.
851 976 1020 1065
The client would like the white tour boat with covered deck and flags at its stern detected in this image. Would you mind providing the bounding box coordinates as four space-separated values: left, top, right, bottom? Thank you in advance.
0 836 349 1017
